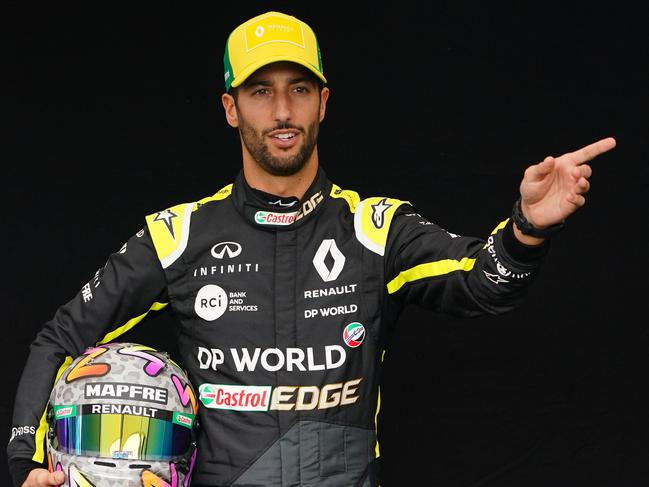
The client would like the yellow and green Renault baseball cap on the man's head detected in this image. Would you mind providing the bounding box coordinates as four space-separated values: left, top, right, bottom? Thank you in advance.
223 12 327 91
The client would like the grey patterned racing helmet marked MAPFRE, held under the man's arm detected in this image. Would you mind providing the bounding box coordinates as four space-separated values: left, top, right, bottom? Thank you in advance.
46 343 198 487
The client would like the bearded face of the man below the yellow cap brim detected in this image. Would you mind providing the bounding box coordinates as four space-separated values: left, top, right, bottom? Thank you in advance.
224 62 329 176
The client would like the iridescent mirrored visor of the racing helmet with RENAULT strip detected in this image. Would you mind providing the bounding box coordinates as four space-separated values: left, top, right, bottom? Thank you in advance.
52 404 194 461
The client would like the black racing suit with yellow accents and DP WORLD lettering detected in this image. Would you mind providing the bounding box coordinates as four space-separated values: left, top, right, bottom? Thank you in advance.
8 169 547 487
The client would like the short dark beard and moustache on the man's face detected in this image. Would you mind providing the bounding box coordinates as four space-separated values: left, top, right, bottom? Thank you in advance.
239 117 320 176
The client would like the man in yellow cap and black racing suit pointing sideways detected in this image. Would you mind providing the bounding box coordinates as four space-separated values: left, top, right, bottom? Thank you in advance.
8 8 615 487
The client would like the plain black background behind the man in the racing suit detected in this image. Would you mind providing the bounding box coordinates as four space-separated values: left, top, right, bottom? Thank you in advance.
0 1 649 487
